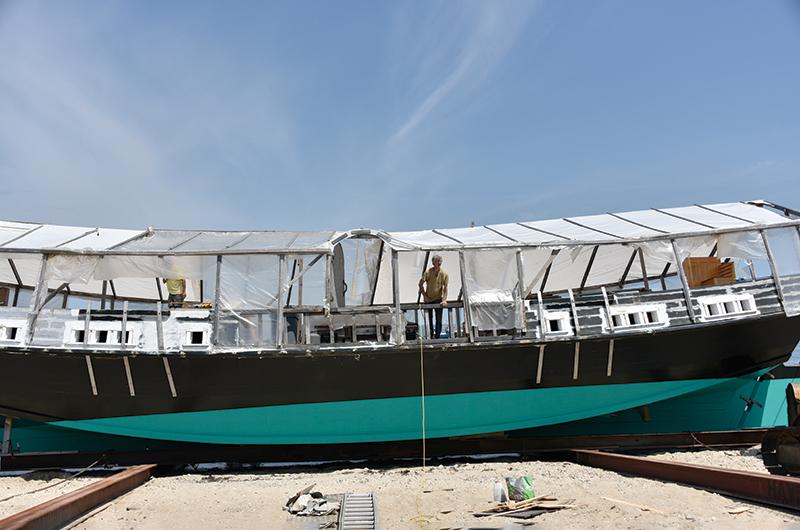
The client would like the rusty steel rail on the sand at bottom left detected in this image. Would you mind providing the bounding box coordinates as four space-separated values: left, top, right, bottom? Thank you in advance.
0 464 156 530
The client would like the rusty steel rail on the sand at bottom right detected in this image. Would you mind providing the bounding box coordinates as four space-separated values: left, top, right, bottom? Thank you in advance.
573 450 800 511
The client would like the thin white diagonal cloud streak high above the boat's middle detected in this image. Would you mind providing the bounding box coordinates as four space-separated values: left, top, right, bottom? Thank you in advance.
390 2 538 142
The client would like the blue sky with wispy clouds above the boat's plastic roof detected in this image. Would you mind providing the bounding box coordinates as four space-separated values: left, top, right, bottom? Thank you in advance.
0 0 800 230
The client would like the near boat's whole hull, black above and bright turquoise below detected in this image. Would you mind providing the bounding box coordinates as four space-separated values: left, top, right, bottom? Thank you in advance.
0 316 800 445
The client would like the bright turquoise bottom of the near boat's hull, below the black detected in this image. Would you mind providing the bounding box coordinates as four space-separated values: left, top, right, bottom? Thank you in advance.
51 379 736 445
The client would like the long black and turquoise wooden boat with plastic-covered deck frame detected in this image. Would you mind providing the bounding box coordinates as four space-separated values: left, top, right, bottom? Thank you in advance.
0 201 800 445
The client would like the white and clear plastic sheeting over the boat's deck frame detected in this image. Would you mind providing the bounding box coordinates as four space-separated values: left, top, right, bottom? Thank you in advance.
0 198 792 316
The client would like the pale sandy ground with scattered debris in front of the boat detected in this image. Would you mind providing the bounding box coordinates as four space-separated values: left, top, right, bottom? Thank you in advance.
0 449 800 530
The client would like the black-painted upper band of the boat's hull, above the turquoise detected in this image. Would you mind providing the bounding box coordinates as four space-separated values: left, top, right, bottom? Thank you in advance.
0 316 800 421
